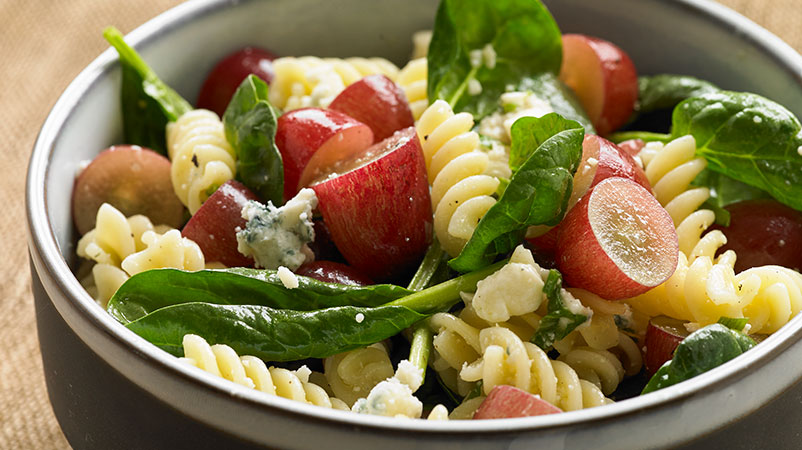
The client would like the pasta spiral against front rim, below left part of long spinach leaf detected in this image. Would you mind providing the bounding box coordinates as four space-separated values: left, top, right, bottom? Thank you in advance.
181 334 350 411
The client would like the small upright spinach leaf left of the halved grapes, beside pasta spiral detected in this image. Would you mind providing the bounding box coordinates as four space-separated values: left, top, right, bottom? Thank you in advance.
223 75 284 206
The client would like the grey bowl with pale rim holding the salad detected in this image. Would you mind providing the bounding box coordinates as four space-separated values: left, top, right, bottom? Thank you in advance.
27 0 802 449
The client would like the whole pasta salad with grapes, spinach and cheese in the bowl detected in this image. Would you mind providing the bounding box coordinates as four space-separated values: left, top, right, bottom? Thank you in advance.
72 0 802 420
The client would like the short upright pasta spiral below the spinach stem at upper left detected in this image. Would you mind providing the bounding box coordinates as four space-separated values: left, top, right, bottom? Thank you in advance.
167 109 237 214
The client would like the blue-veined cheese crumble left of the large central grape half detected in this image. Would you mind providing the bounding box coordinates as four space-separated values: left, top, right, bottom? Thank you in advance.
237 189 317 270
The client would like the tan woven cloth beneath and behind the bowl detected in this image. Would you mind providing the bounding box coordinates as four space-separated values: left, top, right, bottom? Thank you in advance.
0 0 802 449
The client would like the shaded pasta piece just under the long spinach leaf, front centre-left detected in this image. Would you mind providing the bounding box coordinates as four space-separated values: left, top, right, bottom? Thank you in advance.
323 343 394 406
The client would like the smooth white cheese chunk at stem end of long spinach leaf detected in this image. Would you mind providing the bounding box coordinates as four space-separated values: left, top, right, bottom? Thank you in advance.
472 246 544 323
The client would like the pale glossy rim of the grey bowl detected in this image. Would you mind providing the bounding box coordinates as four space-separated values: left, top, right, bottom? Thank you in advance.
26 0 802 435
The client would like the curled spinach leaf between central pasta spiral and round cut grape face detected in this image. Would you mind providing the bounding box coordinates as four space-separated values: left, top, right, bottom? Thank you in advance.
449 113 585 272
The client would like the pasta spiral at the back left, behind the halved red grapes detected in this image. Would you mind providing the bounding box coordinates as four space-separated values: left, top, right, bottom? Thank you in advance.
268 56 398 111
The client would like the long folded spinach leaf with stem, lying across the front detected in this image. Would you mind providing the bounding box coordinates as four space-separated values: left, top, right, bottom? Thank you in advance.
115 261 504 361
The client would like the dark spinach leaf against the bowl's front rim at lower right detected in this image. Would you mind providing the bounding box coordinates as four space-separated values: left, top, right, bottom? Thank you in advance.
642 323 756 394
